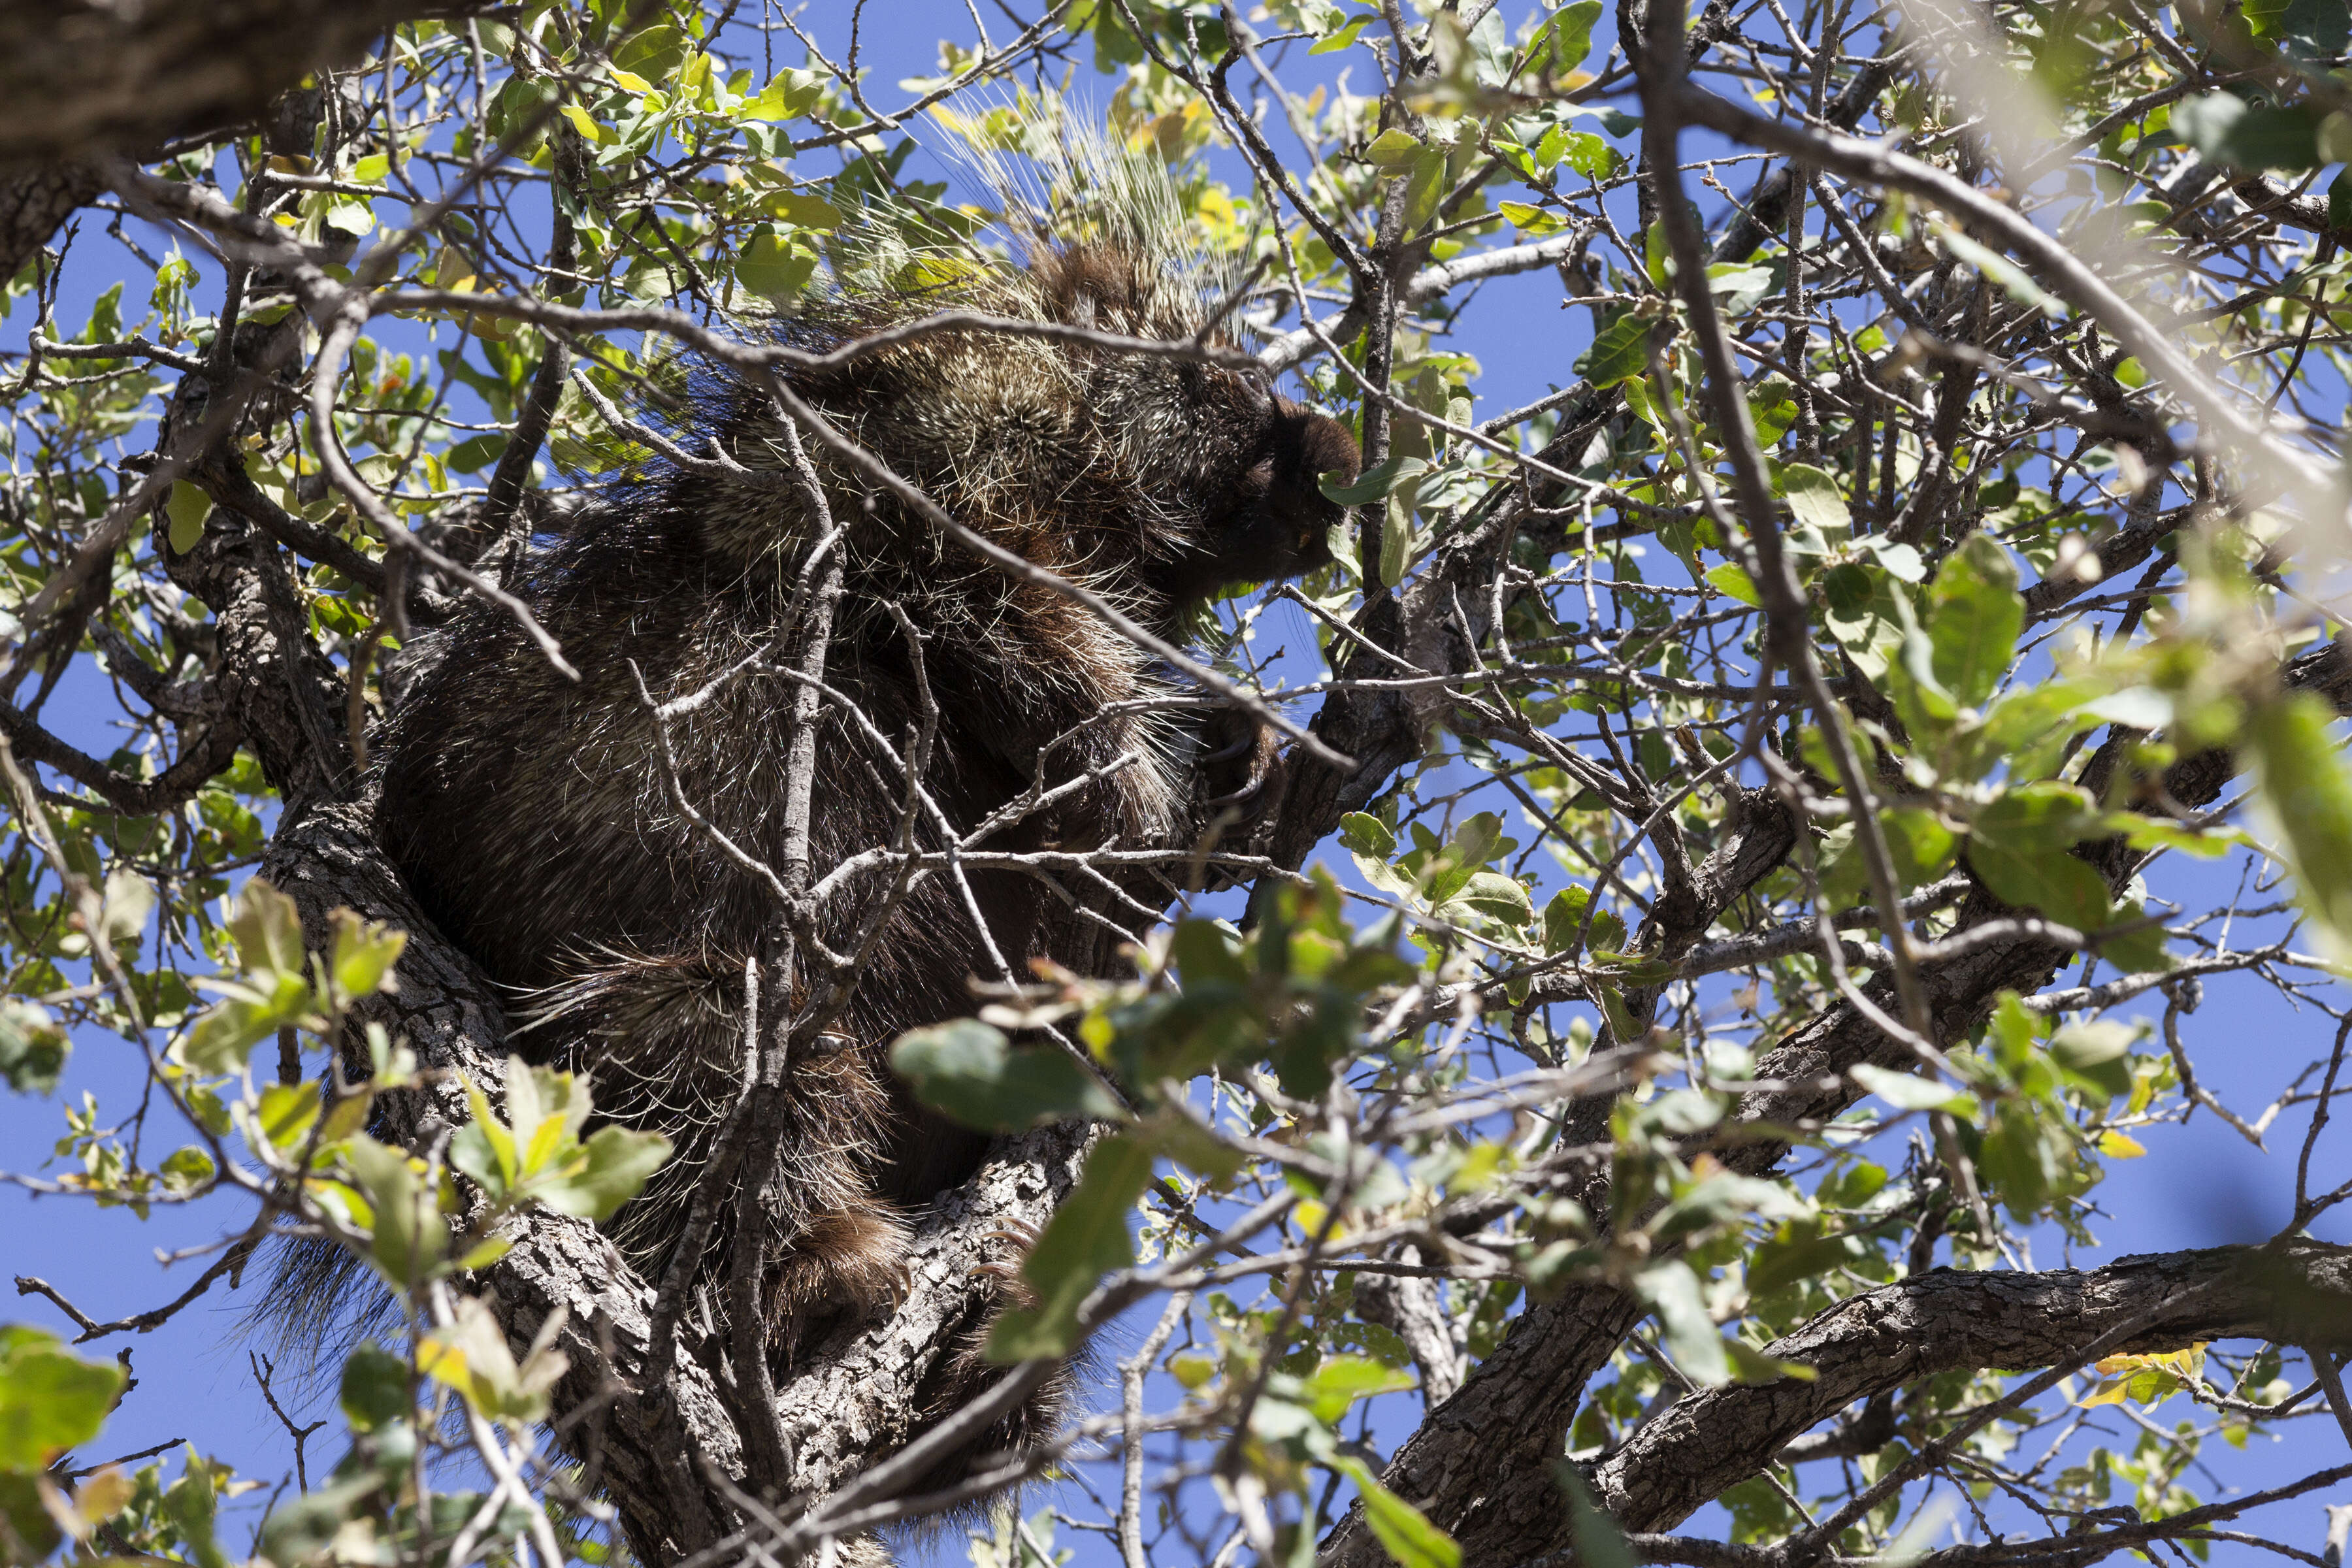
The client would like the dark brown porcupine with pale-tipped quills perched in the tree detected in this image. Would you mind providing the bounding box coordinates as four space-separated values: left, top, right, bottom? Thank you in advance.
379 116 1357 1467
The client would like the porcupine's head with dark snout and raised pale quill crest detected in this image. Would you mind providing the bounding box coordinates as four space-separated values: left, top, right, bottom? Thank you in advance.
687 106 1357 625
